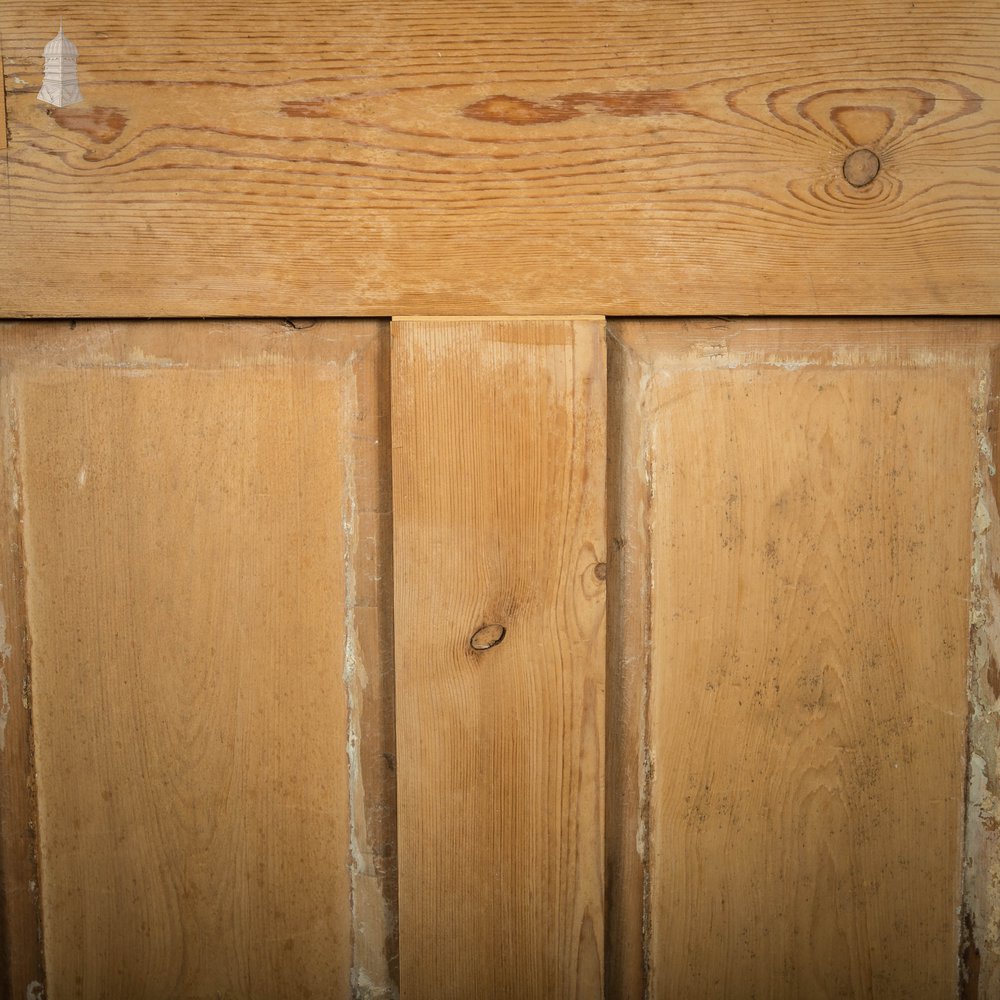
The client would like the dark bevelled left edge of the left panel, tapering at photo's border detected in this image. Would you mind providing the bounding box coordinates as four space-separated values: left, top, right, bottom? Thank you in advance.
0 371 45 1000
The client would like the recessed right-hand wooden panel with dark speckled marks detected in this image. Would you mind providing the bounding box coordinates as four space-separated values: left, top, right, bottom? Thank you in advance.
609 321 984 998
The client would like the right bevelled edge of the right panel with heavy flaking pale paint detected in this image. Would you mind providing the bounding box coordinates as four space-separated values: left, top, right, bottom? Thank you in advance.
959 346 1000 1000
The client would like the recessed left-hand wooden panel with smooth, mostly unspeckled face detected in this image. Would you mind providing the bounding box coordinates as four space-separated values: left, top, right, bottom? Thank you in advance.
0 322 395 998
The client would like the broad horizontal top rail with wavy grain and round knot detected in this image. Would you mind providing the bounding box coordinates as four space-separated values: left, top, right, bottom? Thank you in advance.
0 0 1000 316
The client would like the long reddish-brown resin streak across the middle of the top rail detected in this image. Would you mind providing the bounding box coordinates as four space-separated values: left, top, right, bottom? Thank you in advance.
462 90 688 125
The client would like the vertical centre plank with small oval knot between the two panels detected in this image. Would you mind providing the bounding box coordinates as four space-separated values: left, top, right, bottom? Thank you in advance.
392 319 606 1000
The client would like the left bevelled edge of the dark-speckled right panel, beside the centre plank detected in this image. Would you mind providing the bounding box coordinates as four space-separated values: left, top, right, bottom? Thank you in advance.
605 327 650 1000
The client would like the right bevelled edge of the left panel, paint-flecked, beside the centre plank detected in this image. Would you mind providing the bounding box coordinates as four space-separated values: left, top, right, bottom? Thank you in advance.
343 329 399 1000
